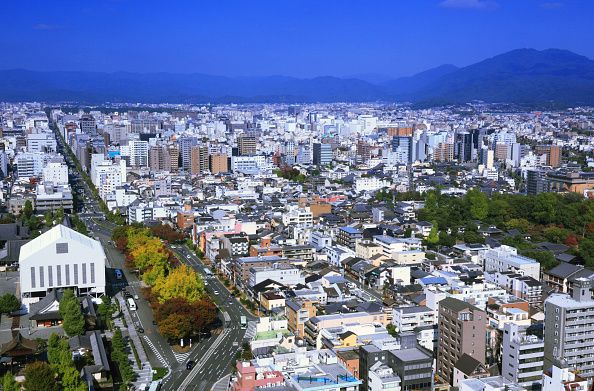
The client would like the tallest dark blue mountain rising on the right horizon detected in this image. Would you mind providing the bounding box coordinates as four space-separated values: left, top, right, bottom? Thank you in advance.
408 49 594 105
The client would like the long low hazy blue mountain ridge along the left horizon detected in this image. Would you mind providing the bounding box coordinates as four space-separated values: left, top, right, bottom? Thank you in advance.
0 70 389 103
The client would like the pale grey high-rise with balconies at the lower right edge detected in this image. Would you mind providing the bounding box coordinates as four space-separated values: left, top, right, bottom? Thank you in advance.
544 278 594 378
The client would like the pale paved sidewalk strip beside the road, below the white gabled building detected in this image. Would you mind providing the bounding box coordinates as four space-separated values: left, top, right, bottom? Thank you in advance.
114 293 153 389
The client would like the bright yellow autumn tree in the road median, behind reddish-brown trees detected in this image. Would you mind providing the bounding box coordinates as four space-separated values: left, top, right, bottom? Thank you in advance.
153 264 204 303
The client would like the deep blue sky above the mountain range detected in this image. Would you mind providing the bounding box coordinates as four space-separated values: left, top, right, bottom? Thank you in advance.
0 0 594 77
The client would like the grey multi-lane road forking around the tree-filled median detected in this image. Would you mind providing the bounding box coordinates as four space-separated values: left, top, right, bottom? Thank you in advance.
49 119 254 390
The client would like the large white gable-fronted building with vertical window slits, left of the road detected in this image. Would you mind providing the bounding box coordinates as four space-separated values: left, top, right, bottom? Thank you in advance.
19 225 106 306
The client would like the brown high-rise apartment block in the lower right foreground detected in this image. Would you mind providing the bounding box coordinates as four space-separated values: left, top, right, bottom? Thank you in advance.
437 297 487 384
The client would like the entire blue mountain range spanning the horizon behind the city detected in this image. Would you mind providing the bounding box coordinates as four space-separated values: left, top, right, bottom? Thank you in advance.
0 49 594 106
